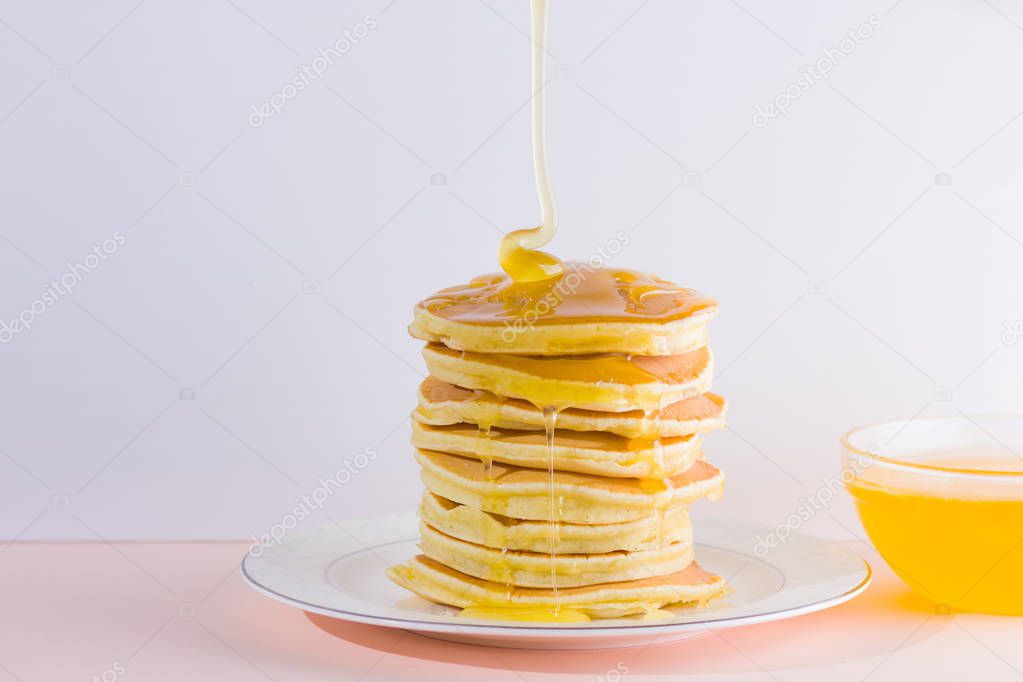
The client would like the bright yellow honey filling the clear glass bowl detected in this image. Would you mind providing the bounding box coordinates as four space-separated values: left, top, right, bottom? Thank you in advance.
847 451 1023 616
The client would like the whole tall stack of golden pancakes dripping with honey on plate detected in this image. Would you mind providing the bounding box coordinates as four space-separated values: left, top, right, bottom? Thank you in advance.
389 264 725 620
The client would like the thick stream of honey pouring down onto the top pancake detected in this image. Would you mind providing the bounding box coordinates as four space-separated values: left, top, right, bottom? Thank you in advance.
498 0 564 282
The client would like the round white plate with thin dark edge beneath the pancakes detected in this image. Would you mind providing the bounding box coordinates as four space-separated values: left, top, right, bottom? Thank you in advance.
241 515 871 649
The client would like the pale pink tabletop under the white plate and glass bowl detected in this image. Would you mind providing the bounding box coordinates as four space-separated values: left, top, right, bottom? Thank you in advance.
0 542 1023 682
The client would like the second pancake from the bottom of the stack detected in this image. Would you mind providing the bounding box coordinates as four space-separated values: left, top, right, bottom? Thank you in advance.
419 521 693 588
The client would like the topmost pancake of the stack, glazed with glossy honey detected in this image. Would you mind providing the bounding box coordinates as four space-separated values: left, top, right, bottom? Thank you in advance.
409 263 717 355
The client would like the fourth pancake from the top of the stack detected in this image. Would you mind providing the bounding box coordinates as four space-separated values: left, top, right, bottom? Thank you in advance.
412 420 703 479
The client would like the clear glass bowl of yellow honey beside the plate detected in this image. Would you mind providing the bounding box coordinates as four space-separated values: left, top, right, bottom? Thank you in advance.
842 415 1023 616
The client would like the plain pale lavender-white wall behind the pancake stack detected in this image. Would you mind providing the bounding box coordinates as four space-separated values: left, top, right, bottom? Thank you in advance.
0 0 1023 538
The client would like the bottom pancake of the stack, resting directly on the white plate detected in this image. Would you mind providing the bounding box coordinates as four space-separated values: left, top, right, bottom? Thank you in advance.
388 554 724 618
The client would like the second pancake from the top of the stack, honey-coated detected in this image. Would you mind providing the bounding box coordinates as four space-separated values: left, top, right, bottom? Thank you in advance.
422 344 714 412
